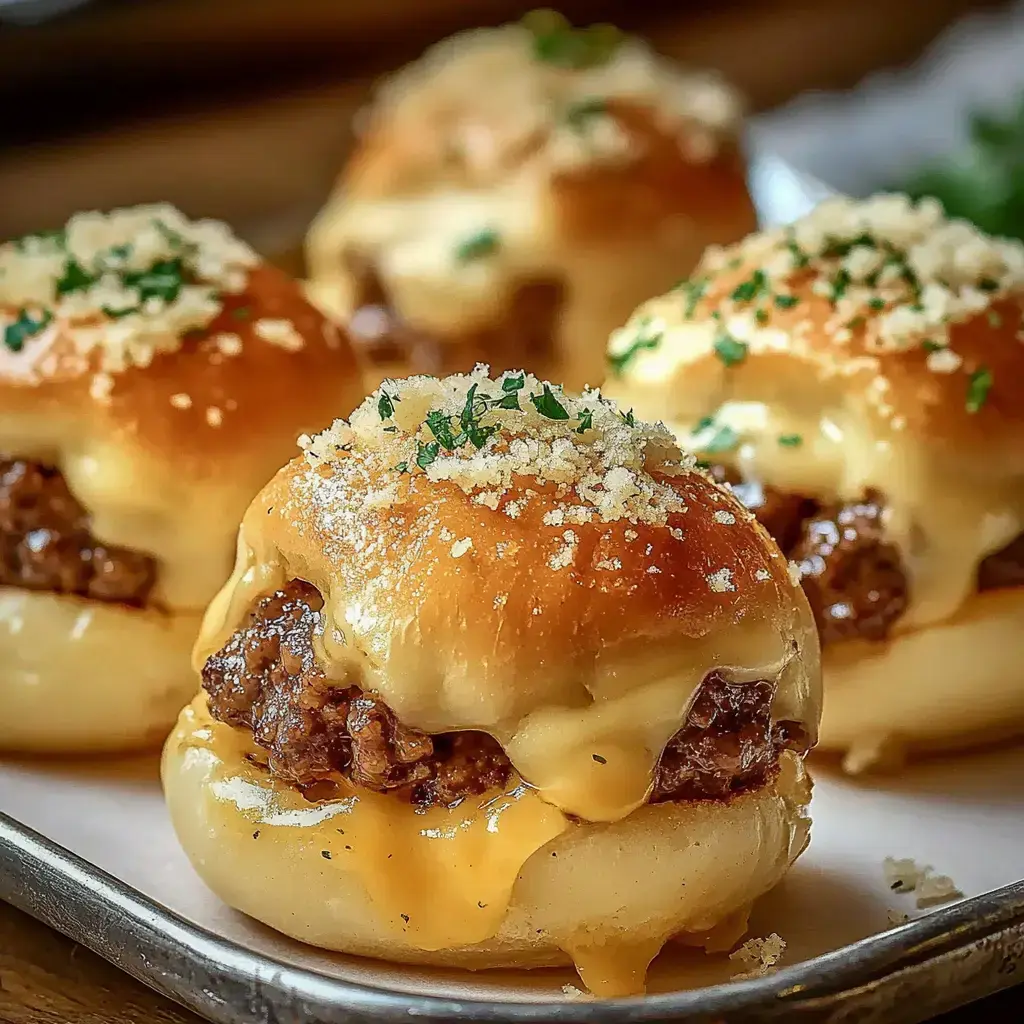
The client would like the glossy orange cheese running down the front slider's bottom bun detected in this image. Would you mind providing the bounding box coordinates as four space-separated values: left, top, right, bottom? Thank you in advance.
173 696 567 950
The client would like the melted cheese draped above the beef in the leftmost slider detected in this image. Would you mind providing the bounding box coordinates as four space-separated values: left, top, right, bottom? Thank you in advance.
0 412 268 612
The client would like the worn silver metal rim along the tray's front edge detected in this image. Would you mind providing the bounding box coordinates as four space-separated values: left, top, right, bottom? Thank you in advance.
0 812 1024 1024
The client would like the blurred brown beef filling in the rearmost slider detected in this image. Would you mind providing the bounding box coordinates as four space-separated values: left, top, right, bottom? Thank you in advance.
346 254 565 376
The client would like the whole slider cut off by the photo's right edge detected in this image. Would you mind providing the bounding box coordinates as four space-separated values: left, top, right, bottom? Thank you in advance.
609 195 1024 770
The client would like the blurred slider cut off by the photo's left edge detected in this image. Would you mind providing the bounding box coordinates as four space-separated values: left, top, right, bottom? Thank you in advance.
0 206 356 752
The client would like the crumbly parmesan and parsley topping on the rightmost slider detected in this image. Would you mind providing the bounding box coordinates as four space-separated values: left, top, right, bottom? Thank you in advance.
608 194 1024 413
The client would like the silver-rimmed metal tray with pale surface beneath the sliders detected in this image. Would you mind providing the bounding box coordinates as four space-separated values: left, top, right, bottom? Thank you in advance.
0 155 1024 1024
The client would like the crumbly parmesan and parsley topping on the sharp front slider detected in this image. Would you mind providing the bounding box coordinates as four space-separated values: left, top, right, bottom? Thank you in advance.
300 366 695 528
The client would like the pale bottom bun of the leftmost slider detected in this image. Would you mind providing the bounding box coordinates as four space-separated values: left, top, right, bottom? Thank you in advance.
0 587 201 754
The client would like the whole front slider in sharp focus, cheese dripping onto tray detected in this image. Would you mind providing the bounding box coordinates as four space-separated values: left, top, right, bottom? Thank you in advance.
163 368 819 995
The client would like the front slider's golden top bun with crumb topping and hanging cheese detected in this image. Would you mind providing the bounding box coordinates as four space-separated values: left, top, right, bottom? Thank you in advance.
197 367 818 819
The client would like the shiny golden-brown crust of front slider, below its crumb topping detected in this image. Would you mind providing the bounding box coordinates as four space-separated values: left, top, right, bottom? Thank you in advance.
243 453 807 678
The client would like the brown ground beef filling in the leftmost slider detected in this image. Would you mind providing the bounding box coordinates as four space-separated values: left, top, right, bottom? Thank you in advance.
0 458 157 607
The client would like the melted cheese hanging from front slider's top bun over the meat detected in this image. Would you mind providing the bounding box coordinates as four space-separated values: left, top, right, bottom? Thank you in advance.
194 520 817 821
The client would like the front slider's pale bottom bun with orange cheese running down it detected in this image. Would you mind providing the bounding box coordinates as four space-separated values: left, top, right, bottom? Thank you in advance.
163 696 810 995
